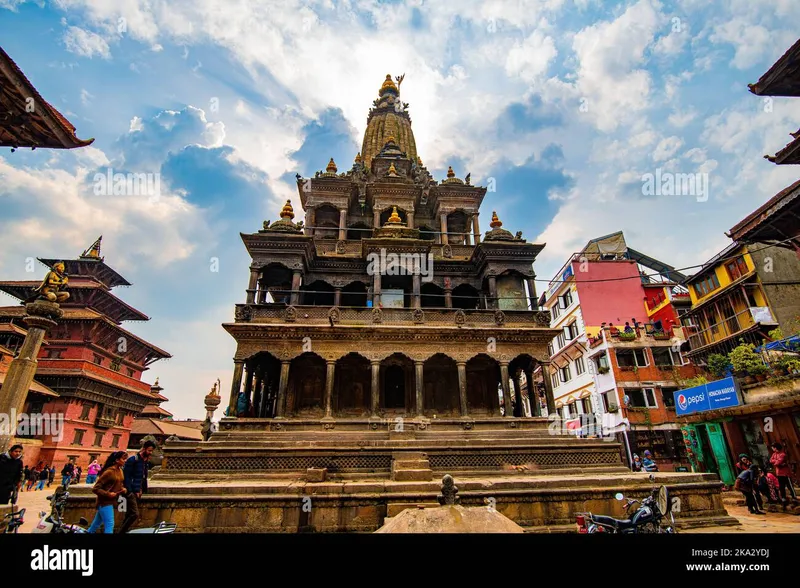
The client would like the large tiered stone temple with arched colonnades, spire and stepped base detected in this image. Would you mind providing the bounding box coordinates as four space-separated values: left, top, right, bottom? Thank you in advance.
74 75 731 532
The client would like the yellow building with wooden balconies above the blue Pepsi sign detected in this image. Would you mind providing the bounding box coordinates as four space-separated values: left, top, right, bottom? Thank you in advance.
683 243 778 359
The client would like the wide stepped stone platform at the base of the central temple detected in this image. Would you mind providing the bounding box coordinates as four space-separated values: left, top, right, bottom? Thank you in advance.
62 418 736 533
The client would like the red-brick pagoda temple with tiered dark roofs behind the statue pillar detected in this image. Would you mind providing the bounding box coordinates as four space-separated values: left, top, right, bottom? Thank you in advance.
0 237 171 469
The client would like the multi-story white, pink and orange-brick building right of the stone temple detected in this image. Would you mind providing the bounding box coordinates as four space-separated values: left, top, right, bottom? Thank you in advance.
540 232 696 469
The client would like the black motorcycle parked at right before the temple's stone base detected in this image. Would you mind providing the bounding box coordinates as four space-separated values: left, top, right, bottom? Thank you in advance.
575 474 675 535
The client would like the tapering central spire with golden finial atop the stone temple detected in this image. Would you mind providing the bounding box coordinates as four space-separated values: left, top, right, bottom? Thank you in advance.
361 74 417 168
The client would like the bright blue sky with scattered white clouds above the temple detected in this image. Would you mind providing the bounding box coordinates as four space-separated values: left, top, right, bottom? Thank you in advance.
0 0 800 418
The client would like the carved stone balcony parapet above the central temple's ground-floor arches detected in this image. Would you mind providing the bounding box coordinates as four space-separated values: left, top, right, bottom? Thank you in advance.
231 304 550 329
